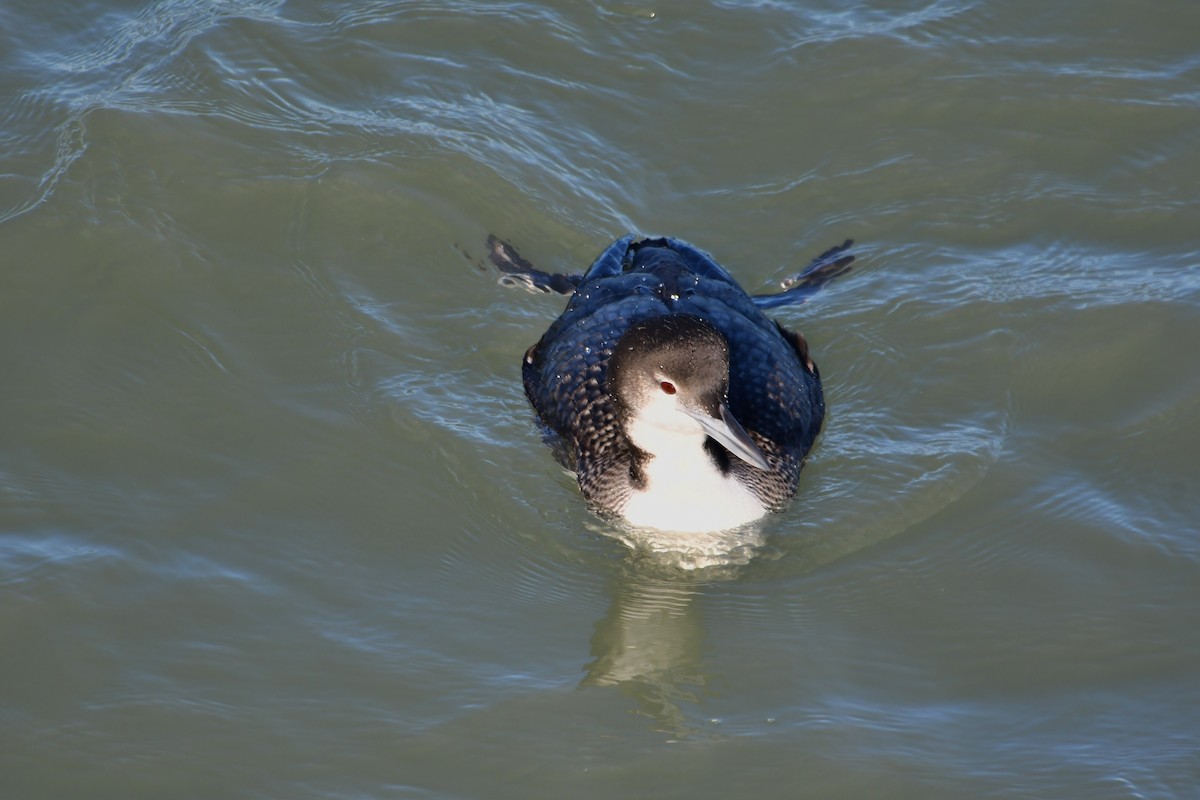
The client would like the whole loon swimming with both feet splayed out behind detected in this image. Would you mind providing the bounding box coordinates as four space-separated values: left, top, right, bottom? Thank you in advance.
488 235 854 533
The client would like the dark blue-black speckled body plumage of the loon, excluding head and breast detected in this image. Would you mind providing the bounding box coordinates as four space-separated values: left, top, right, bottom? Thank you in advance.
517 236 830 516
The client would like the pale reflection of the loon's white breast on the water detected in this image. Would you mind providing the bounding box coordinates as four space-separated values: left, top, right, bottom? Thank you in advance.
582 529 762 735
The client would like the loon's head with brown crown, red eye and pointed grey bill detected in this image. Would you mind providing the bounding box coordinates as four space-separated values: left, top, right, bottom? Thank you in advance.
608 314 770 470
